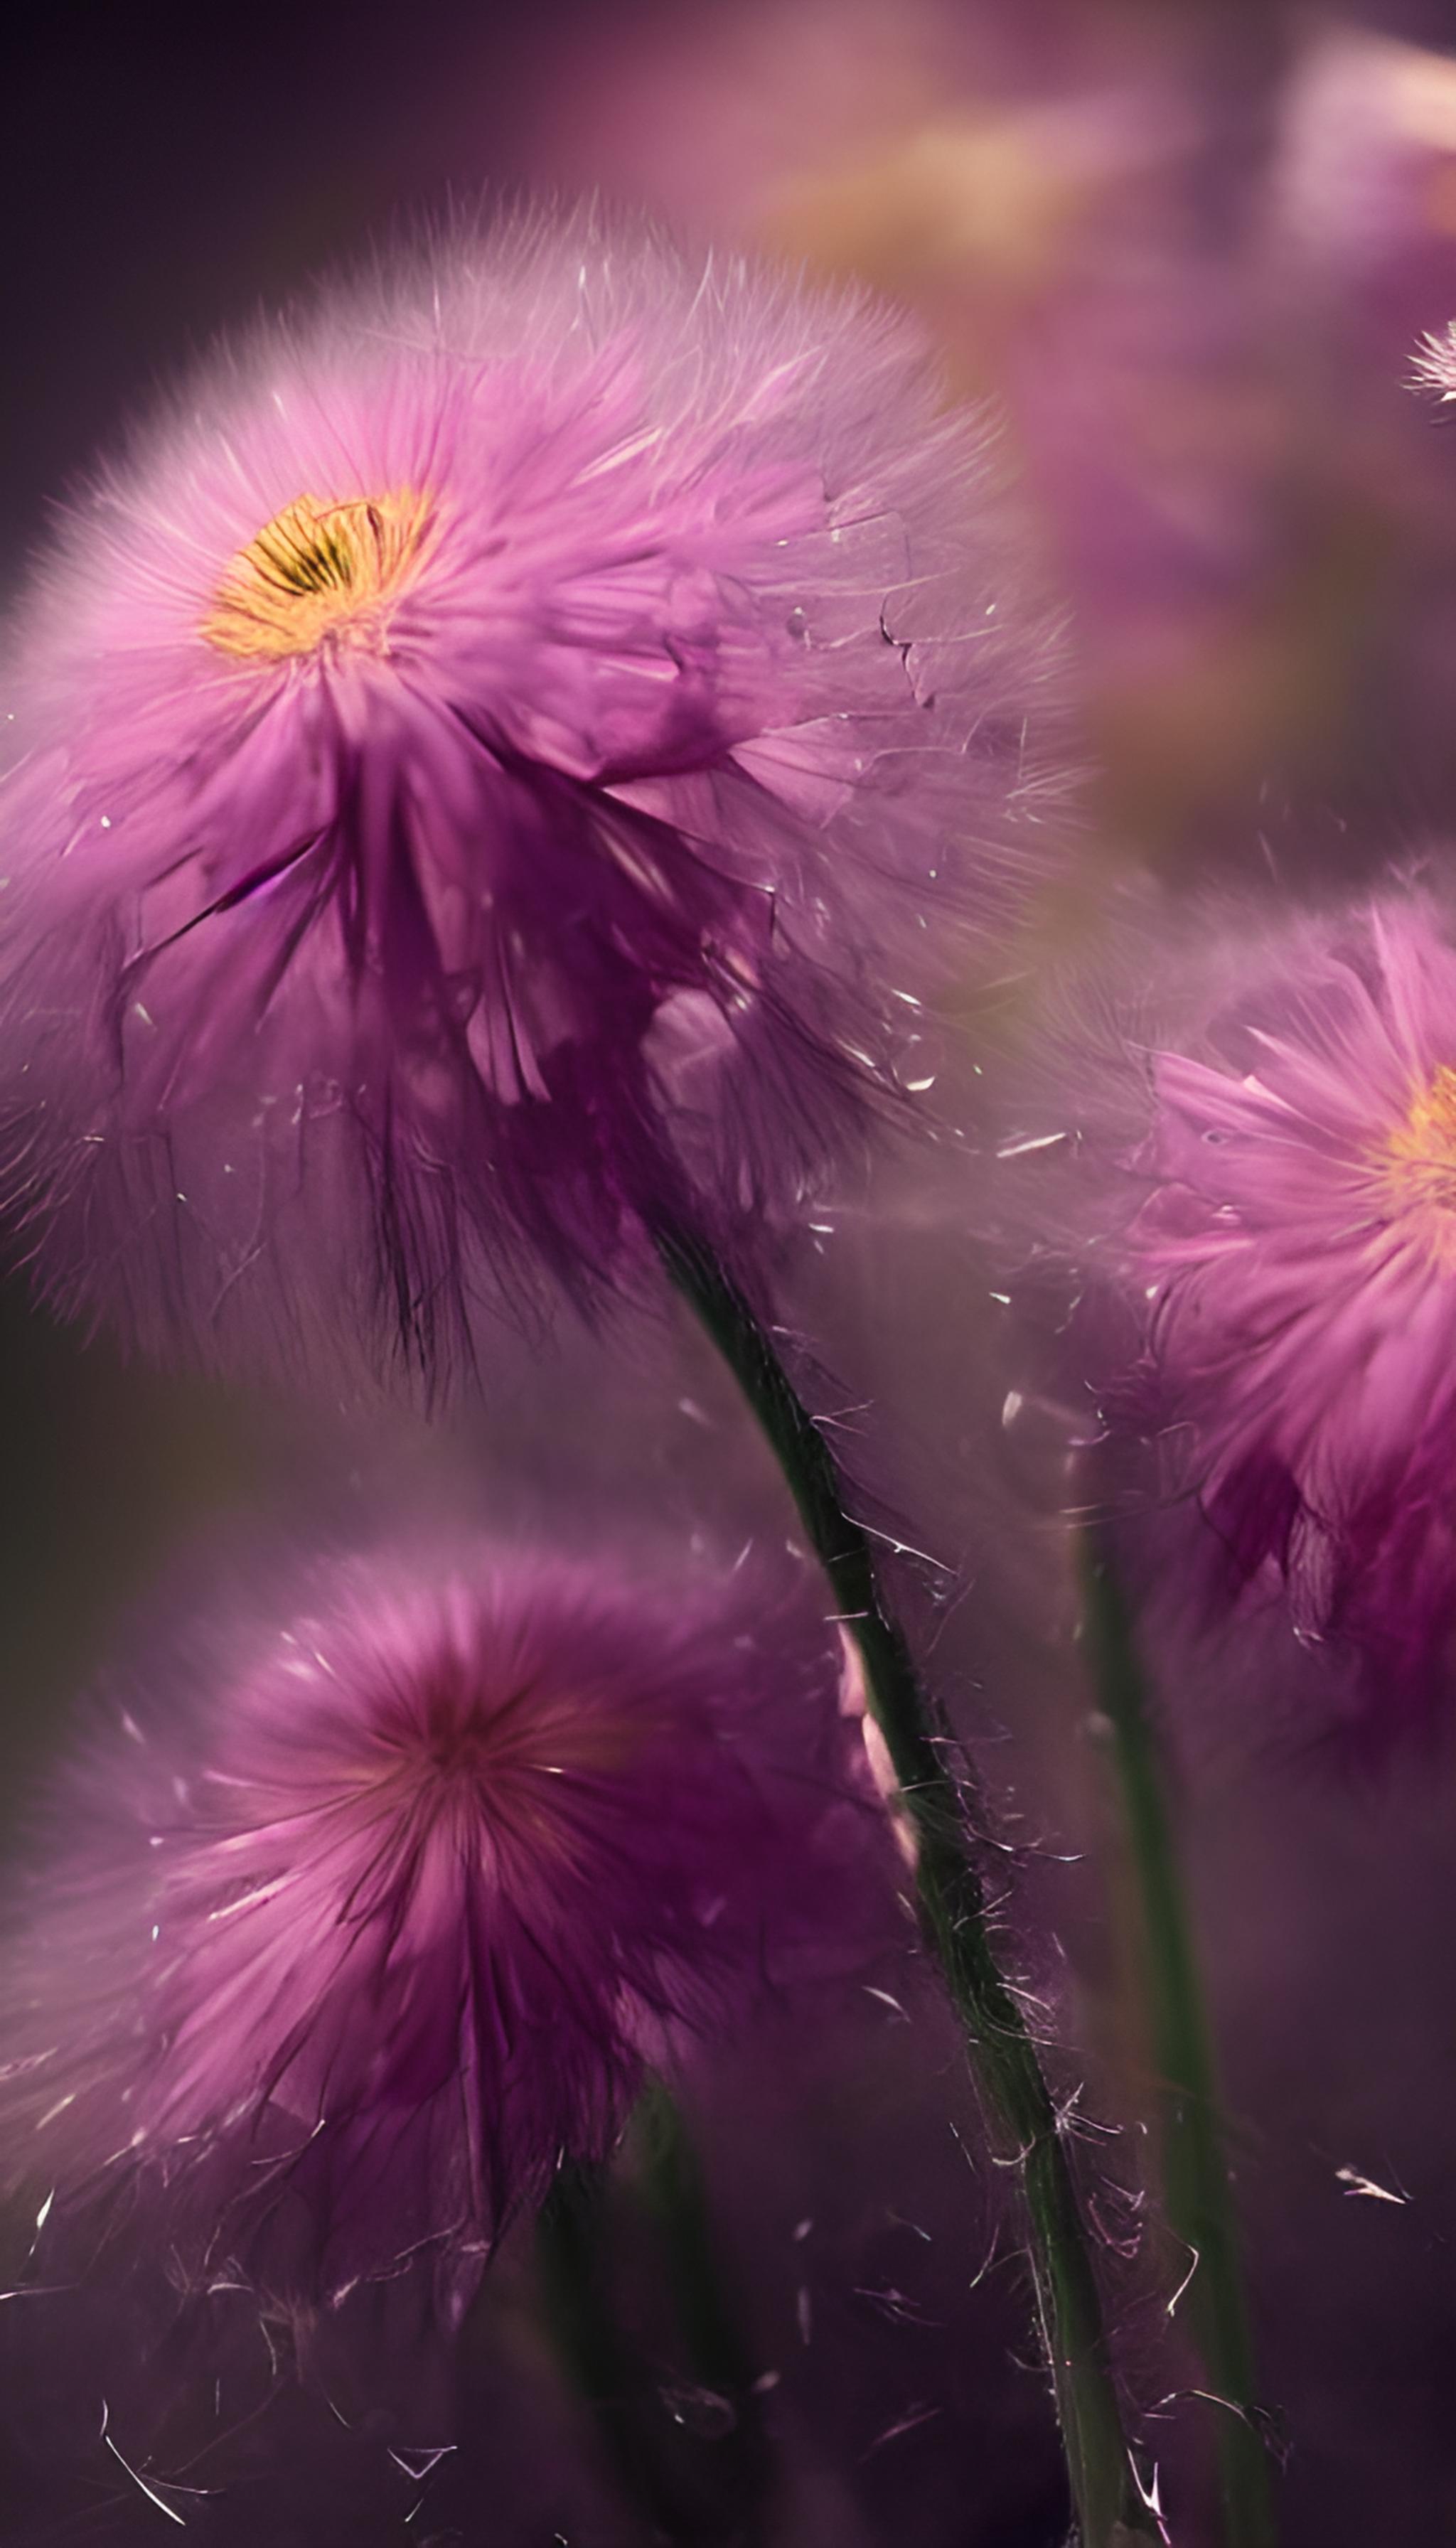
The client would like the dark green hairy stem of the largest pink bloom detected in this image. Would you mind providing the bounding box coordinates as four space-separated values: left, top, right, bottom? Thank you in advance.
653 1223 1157 2548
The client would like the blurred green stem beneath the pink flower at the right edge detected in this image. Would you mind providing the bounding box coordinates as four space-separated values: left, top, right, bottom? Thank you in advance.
1081 1524 1275 2548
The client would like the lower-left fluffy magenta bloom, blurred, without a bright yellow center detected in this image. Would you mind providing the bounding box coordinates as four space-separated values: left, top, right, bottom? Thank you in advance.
0 1546 887 2321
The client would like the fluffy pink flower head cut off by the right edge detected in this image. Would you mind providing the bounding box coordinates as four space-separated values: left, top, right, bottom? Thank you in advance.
1125 899 1456 1712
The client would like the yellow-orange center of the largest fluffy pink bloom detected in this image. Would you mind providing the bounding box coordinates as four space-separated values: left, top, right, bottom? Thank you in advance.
201 487 431 663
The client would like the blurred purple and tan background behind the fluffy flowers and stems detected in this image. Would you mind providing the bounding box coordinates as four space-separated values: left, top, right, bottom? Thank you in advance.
0 0 1456 2548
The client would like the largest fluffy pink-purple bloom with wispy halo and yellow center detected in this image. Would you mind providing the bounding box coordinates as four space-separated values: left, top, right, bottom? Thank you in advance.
0 219 1056 1388
